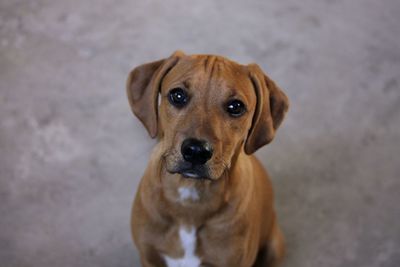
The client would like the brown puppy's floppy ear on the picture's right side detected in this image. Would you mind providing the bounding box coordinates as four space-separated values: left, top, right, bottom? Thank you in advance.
245 64 289 154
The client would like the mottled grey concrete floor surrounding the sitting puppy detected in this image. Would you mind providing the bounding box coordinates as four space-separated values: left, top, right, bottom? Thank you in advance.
0 0 400 267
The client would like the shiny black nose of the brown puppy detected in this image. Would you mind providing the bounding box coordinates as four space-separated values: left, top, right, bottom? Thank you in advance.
181 138 213 164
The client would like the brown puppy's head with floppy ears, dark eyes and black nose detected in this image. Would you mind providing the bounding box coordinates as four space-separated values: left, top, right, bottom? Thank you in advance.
127 51 288 180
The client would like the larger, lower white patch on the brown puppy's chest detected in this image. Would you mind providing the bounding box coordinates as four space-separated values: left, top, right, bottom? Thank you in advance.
164 227 200 267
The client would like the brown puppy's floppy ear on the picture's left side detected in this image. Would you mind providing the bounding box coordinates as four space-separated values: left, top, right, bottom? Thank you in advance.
126 51 184 138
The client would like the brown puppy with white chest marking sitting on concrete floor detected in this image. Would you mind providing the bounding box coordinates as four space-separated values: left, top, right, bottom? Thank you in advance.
127 51 288 267
